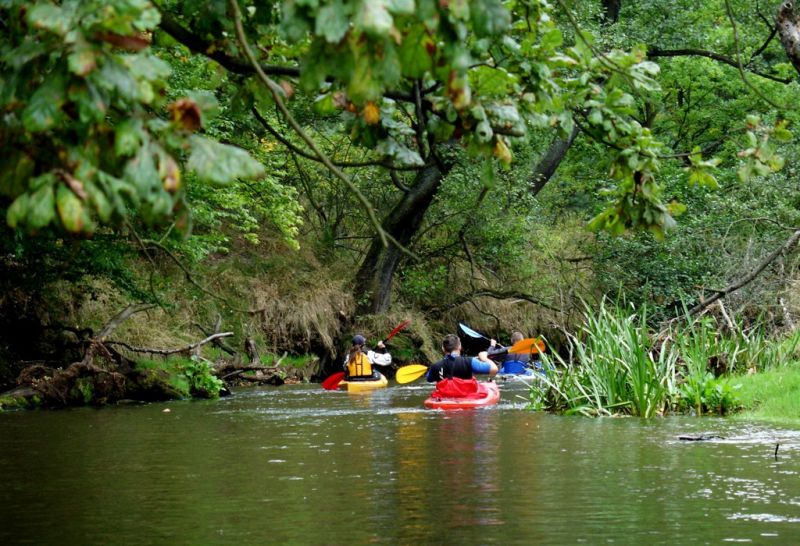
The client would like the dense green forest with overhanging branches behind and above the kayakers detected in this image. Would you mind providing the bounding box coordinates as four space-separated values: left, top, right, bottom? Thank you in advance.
0 0 800 400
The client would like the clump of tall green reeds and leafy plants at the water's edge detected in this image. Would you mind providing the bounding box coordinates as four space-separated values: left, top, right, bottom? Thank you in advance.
531 304 752 417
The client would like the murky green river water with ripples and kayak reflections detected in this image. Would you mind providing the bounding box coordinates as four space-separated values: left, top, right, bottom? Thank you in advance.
0 378 800 545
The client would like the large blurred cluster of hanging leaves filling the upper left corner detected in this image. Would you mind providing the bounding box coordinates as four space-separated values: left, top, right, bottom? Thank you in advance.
0 0 263 234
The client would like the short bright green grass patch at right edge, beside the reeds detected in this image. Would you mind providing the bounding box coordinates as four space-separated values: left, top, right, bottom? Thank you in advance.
731 361 800 423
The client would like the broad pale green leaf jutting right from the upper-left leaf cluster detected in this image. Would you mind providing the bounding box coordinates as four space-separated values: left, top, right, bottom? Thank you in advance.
186 135 264 184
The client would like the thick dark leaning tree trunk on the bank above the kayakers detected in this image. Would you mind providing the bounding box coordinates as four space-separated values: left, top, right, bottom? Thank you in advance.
356 165 450 313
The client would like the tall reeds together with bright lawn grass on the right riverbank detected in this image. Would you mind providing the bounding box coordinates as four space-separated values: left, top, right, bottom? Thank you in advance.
531 305 800 420
